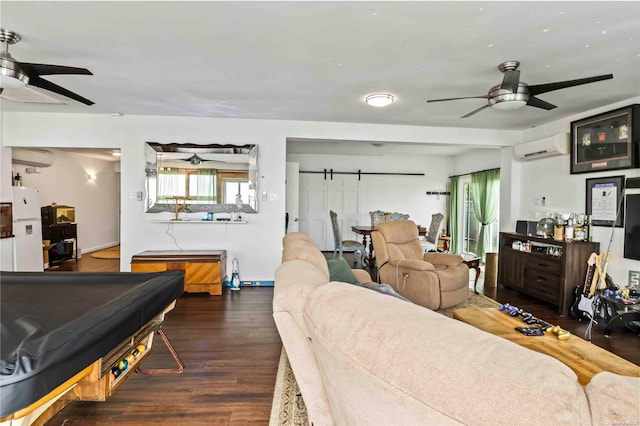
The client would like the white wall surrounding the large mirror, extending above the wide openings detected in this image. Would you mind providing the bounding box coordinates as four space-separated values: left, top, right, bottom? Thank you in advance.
2 112 519 281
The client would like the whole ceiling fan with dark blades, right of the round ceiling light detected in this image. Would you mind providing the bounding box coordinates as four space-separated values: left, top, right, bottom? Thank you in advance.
427 61 613 118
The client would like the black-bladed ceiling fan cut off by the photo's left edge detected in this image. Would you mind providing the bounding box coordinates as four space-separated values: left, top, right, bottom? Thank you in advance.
0 28 93 105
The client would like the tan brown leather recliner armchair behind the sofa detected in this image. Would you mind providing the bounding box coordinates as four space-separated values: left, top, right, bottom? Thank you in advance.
371 220 469 310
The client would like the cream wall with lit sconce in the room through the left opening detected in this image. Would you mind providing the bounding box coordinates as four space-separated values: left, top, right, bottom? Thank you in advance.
12 149 120 253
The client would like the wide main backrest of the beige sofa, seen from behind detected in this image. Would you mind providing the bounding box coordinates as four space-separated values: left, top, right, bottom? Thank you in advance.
304 282 590 425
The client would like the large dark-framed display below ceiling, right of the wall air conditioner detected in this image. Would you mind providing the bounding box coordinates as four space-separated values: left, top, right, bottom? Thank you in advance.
571 104 640 174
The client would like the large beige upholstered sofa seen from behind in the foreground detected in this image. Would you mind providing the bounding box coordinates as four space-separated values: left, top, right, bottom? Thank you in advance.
273 233 640 426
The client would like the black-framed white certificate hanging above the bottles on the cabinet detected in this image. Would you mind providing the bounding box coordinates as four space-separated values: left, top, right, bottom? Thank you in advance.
585 175 624 228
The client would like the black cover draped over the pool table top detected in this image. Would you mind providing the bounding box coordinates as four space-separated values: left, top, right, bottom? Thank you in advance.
0 271 184 417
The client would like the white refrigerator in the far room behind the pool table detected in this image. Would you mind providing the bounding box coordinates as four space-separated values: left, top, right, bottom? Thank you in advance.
12 186 44 272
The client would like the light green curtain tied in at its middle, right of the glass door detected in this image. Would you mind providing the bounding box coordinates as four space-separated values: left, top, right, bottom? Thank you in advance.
470 169 500 259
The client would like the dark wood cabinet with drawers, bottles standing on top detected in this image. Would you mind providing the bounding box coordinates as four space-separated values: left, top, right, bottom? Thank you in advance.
498 232 600 316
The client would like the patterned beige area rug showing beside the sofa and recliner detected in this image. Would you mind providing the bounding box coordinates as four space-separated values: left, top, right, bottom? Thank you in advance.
269 290 500 426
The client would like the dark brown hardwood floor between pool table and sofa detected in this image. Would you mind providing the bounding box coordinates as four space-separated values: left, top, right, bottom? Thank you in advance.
42 253 640 426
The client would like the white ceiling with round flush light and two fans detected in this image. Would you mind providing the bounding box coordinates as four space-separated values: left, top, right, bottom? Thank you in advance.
0 0 640 156
